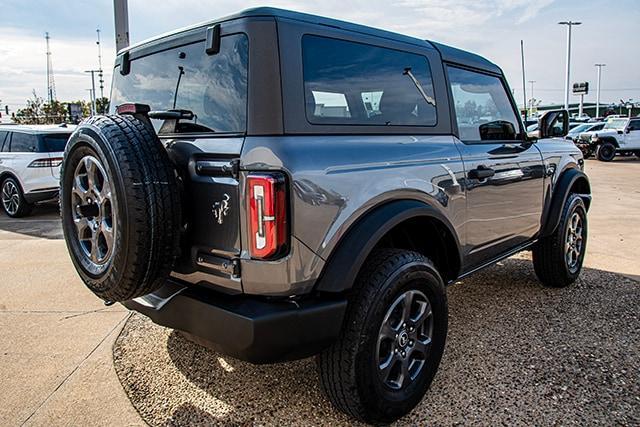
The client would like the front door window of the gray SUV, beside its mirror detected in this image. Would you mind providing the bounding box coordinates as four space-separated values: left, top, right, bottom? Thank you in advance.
448 67 521 142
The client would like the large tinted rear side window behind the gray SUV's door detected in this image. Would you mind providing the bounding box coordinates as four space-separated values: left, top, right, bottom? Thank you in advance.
302 35 437 126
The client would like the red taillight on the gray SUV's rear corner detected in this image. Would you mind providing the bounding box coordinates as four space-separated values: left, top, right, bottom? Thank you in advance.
247 174 288 259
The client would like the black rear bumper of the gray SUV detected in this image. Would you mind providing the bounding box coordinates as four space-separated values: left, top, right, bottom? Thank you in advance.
123 281 347 364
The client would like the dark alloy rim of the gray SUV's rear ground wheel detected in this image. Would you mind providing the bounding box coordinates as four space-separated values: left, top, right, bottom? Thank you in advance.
376 289 433 390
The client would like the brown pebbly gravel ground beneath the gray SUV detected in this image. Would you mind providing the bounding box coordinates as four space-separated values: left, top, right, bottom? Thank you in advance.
113 256 640 425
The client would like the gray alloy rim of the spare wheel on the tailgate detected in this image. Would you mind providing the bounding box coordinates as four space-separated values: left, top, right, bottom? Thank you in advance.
71 155 116 273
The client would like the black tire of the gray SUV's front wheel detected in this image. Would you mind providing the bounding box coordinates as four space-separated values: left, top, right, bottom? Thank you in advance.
533 194 587 288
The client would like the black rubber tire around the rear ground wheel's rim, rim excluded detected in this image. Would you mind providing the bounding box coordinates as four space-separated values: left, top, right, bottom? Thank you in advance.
316 249 448 424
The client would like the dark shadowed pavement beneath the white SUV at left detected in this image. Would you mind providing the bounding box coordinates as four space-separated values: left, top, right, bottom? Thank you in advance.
0 202 64 239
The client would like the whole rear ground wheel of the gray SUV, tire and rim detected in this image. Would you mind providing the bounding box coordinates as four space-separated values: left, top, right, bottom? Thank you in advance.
317 249 448 424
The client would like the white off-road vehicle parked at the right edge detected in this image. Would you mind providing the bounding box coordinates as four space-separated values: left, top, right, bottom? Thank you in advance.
576 117 640 162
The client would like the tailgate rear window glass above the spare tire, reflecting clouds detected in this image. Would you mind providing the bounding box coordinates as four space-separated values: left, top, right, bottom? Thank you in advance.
111 34 248 133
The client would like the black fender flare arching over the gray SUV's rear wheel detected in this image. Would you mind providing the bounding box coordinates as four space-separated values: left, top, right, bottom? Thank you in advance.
315 200 462 293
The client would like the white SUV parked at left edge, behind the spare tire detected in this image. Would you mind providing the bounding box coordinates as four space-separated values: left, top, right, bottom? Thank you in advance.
0 125 73 217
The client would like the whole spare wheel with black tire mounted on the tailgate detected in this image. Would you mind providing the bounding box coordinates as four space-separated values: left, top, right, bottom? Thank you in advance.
60 115 181 302
